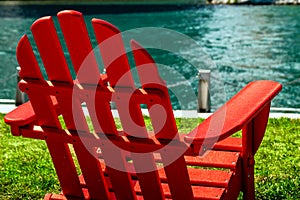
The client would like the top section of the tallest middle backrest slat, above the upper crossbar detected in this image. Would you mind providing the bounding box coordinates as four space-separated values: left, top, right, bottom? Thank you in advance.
57 10 102 84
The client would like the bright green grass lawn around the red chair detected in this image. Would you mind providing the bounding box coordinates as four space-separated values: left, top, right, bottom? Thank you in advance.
0 114 300 200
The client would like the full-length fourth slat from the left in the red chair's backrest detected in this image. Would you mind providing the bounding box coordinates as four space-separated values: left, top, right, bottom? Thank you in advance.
93 19 164 199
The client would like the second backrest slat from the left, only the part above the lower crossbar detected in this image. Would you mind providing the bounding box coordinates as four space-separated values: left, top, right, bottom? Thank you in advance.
31 14 87 130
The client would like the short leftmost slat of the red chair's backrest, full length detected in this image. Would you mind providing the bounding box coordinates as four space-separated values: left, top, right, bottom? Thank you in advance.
17 29 83 196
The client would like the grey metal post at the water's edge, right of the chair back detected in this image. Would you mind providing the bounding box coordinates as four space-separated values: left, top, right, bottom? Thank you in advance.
198 70 210 113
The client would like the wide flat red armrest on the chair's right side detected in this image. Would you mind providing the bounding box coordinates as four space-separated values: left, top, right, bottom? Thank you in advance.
184 80 282 153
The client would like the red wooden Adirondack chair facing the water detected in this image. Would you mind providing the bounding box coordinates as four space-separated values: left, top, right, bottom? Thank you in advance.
5 11 281 199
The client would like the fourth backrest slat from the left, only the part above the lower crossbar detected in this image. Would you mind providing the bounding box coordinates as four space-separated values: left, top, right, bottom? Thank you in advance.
92 19 152 137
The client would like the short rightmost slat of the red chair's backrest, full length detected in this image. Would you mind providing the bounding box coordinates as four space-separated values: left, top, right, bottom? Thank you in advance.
131 41 193 199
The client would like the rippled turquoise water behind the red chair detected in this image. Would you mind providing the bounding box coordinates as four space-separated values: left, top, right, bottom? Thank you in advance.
0 6 300 109
